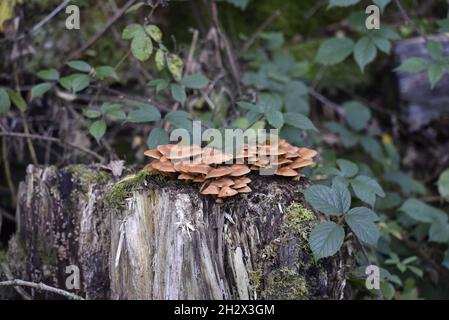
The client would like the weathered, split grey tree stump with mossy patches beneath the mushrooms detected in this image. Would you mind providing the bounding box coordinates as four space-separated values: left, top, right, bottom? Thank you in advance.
2 166 346 299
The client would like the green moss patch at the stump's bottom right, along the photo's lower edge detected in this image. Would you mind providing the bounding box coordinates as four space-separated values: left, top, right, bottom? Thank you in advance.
262 268 309 300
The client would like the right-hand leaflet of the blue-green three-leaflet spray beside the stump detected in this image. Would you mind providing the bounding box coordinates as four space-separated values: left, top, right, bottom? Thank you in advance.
345 207 379 246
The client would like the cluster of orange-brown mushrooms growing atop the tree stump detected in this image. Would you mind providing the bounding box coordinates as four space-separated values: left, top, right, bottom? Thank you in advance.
144 140 317 199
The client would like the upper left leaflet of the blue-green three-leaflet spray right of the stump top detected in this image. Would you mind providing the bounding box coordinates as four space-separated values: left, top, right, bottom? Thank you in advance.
303 185 351 216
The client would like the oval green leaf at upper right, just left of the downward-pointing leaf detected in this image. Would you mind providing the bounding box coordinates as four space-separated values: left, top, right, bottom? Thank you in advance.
315 38 354 65
